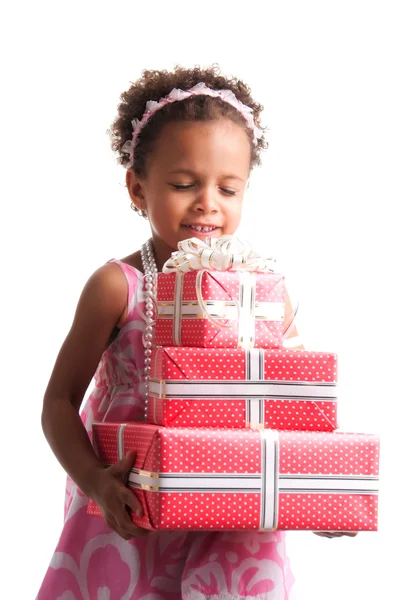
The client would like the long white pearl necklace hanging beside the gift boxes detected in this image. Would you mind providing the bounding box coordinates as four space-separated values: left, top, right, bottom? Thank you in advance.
141 240 158 421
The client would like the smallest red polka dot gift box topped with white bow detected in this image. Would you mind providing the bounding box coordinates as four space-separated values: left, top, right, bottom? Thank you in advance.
155 236 285 348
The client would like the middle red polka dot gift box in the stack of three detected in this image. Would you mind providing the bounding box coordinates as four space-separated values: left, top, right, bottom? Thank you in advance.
147 347 337 431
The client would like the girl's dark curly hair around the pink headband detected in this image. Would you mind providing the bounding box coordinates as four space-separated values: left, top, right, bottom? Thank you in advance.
109 65 268 175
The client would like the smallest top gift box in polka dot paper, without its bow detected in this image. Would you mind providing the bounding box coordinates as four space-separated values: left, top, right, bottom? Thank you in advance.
155 271 285 348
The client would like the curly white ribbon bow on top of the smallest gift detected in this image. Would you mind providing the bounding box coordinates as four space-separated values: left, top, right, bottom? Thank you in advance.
163 235 275 273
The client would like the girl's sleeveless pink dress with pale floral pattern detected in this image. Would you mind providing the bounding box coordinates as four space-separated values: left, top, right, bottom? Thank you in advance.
36 259 293 600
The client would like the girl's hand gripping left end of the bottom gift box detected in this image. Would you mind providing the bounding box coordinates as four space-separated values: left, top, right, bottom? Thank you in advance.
91 452 150 540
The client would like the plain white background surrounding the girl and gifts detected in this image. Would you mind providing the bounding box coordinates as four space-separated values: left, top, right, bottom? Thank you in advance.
0 0 398 600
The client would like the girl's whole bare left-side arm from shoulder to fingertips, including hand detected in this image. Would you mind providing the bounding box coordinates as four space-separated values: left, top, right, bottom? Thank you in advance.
42 264 148 539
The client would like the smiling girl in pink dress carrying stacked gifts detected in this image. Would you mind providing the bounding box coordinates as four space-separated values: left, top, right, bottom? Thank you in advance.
37 67 338 600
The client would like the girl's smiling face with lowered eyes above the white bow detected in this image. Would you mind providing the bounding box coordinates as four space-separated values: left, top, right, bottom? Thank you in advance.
127 119 250 267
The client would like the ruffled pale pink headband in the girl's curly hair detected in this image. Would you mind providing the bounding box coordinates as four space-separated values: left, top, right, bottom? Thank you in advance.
122 82 263 169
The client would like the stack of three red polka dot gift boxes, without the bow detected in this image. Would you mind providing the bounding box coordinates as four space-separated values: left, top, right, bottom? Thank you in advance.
89 246 379 531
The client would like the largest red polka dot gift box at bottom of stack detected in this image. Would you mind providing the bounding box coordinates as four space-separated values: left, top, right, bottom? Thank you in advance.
88 422 379 531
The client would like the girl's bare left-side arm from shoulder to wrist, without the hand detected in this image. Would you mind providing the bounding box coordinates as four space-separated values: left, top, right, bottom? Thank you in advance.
42 265 127 495
